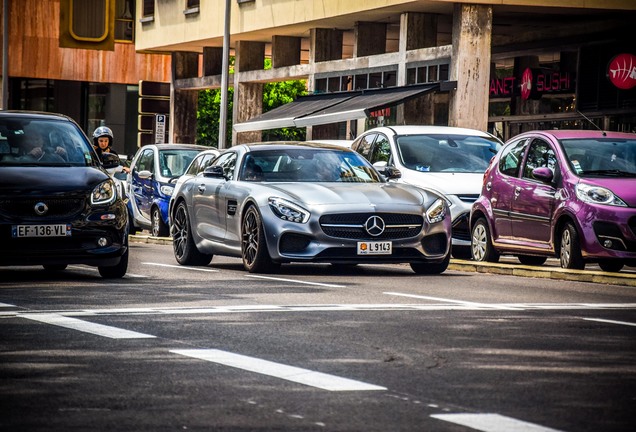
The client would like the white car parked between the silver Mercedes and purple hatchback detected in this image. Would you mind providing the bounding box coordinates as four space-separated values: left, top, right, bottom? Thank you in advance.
351 126 503 259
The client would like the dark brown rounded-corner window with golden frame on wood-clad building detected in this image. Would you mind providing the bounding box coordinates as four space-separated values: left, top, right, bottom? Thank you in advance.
69 0 109 42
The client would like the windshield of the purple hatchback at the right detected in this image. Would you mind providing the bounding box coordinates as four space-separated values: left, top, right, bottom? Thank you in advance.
561 138 636 177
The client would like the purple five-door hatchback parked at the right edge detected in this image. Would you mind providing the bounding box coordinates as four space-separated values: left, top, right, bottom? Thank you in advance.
470 130 636 271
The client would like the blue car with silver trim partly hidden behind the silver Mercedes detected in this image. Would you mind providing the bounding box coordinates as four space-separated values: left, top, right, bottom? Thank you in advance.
128 144 209 237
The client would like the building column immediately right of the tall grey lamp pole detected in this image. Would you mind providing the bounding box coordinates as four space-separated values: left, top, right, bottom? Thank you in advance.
232 41 265 145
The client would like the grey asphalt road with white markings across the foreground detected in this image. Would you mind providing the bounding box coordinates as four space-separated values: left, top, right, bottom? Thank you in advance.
0 243 636 432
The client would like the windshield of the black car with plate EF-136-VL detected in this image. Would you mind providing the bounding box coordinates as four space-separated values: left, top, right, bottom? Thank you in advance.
0 117 98 166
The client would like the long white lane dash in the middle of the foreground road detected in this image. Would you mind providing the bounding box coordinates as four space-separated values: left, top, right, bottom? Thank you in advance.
170 349 386 391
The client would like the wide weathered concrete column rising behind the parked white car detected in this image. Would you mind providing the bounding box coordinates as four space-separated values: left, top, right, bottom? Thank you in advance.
448 4 492 131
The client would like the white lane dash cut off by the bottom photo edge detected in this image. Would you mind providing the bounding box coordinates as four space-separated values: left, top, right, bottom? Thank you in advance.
431 414 559 432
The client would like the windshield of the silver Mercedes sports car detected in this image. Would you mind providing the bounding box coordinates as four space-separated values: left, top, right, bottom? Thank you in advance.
240 148 382 183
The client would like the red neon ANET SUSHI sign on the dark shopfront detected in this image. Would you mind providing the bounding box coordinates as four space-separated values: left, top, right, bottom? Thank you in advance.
490 68 574 99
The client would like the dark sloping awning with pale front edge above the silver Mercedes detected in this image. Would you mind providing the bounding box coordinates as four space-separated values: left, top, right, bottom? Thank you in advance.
234 84 439 132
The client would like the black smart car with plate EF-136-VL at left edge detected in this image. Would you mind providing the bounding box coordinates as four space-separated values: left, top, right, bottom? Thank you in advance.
0 111 128 278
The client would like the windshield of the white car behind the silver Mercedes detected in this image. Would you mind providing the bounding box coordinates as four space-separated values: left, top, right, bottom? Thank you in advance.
396 134 500 173
